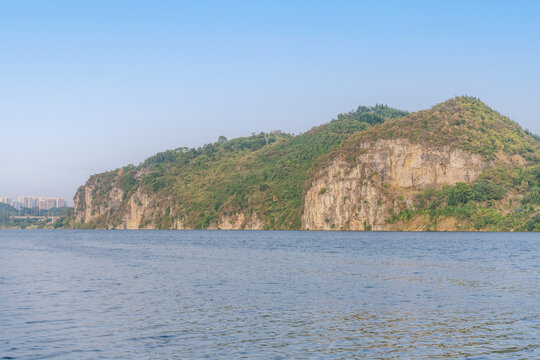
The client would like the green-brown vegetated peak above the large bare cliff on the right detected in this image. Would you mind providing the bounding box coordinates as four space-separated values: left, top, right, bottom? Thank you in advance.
339 96 538 161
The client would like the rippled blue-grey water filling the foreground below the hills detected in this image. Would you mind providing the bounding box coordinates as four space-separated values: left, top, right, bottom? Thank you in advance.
0 230 540 359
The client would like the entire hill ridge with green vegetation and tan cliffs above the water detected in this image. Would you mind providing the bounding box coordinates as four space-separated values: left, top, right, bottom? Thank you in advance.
71 97 540 231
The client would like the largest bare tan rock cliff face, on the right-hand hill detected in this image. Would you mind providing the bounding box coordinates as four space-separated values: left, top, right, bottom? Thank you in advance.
302 140 488 230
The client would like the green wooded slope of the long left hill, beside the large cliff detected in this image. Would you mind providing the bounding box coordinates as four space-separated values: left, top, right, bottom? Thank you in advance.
82 105 407 229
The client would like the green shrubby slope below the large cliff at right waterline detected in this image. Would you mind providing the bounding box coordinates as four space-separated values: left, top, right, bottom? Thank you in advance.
389 165 540 231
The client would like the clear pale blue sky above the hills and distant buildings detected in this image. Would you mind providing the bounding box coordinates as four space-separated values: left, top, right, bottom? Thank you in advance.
0 0 540 199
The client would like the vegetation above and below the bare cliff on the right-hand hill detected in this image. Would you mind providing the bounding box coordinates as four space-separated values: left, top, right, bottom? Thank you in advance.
329 97 540 231
